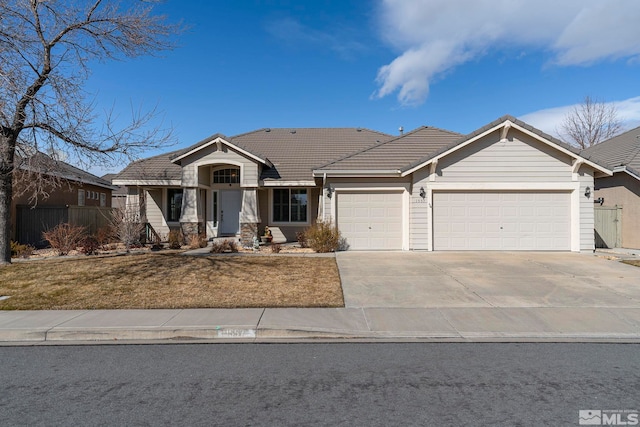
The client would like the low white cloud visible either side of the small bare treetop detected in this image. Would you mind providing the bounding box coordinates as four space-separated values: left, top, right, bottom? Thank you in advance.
518 96 640 137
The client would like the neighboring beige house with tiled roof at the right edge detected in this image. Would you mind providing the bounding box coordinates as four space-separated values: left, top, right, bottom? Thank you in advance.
581 127 640 249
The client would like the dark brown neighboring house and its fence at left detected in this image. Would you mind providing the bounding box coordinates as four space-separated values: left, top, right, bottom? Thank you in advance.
11 153 116 246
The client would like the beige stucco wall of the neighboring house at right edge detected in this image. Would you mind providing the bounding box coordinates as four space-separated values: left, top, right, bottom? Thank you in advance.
594 172 640 249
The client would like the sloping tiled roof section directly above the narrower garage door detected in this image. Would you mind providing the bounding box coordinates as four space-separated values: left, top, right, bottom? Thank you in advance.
319 126 462 171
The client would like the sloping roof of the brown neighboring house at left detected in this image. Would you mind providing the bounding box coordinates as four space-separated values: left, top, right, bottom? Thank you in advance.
15 152 115 189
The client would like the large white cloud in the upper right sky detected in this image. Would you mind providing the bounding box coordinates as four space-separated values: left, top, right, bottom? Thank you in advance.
374 0 640 105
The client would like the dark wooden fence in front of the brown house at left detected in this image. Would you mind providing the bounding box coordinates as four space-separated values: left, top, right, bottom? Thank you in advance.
16 205 112 247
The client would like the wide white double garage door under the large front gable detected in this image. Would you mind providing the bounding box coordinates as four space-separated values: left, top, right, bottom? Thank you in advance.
433 191 571 251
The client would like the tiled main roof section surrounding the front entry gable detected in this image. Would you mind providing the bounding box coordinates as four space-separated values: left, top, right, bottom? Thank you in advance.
117 128 392 186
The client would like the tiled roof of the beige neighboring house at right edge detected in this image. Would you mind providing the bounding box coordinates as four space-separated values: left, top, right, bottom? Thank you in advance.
580 127 640 176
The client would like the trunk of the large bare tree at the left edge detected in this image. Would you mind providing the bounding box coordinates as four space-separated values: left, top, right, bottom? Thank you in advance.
0 132 16 265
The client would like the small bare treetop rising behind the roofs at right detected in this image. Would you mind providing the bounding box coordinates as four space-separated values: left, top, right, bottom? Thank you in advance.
560 96 622 149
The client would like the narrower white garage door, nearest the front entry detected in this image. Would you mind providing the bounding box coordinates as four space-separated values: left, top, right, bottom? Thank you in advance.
336 191 402 250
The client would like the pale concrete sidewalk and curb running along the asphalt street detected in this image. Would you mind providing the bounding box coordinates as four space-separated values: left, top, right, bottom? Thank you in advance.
0 307 640 345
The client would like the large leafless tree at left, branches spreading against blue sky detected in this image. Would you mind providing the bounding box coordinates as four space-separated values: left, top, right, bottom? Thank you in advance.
0 0 181 264
